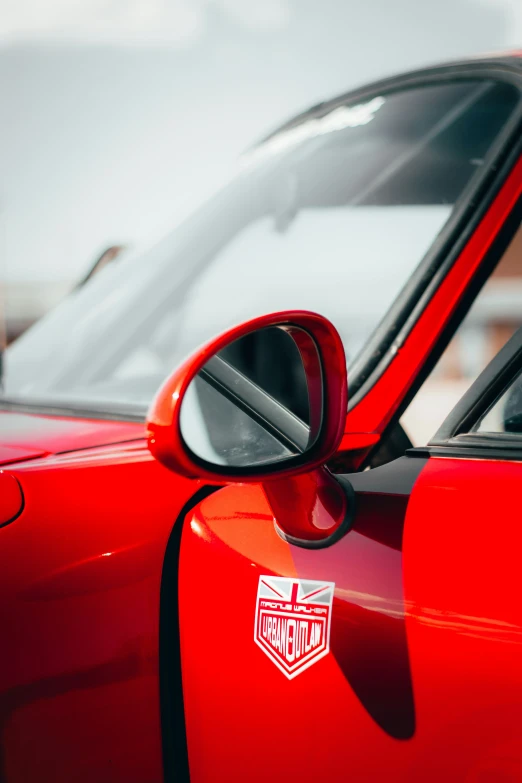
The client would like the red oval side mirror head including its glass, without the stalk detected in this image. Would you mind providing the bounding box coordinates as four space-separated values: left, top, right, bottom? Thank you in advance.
147 311 347 483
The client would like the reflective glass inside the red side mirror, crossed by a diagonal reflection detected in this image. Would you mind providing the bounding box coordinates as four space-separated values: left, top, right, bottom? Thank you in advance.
180 326 323 468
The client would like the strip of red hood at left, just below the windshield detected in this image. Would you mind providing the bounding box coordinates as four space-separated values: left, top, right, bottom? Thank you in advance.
0 411 145 465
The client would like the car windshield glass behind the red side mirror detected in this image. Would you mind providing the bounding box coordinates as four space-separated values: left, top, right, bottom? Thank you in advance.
3 80 518 415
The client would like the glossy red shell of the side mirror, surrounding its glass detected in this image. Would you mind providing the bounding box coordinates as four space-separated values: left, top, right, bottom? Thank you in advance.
147 310 348 484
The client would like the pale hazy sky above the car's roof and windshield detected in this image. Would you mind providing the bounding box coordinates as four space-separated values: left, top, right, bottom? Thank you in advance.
0 0 522 281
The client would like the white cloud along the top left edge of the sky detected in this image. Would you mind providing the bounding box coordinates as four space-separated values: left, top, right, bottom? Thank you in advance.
0 0 290 45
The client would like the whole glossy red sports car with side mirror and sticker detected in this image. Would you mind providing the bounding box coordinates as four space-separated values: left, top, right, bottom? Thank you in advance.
0 54 522 783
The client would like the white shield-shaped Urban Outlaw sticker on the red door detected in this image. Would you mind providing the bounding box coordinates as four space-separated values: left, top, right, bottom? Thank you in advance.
254 576 335 680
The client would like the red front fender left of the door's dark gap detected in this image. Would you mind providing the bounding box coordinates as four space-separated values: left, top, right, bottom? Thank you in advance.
0 444 196 783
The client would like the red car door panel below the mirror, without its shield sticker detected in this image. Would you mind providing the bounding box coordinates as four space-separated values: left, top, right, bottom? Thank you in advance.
179 457 522 783
